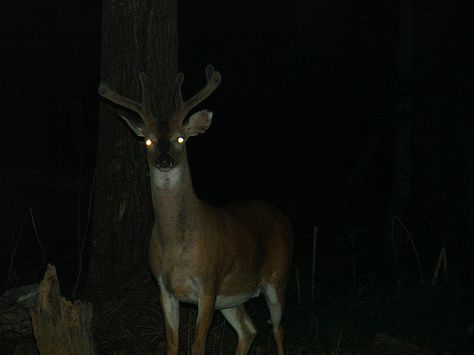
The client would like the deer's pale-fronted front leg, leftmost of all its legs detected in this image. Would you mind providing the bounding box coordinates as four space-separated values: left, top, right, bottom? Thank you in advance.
160 283 179 355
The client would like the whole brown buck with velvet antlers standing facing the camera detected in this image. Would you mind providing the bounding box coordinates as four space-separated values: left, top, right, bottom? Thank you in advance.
99 66 293 355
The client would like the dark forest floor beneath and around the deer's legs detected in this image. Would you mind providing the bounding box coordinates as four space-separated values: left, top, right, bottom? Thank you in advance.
0 260 474 355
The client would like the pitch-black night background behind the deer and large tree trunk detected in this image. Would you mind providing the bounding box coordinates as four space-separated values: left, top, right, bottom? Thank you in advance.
0 0 474 354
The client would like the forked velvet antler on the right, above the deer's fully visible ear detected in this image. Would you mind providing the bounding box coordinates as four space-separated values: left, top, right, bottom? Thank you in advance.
176 65 222 121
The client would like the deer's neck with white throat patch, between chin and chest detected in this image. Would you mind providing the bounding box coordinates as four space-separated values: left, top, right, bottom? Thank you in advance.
150 154 202 242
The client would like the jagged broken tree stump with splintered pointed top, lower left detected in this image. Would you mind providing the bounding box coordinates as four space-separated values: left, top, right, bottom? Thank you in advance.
31 265 94 355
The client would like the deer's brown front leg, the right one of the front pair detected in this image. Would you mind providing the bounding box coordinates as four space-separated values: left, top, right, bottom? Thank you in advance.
193 292 216 355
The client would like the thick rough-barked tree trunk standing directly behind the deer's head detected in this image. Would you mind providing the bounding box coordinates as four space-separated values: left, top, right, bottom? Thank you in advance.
86 0 177 296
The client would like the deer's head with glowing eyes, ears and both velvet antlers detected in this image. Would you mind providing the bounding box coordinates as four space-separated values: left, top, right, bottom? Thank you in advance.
99 65 221 172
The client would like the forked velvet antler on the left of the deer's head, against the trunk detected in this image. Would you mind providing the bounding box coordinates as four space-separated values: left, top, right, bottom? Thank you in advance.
99 73 153 123
